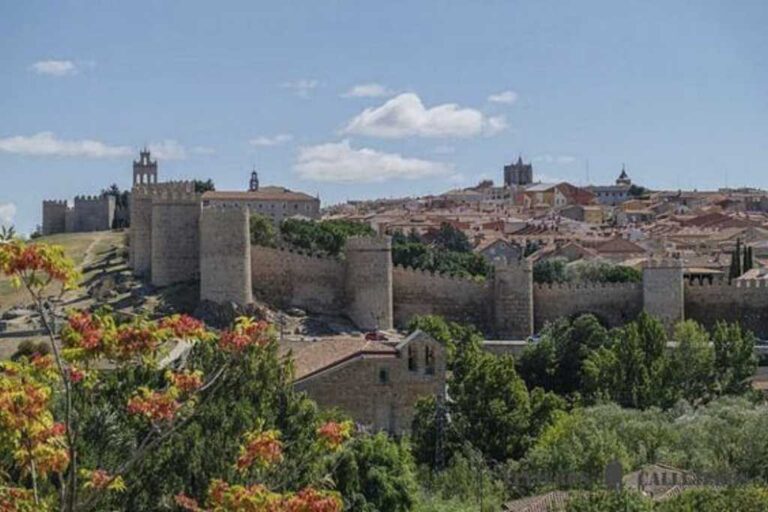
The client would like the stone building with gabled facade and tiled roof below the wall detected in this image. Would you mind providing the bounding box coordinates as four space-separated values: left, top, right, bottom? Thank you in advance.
281 331 445 435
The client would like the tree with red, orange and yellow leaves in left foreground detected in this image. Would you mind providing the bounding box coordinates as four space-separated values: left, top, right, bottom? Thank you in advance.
0 240 351 512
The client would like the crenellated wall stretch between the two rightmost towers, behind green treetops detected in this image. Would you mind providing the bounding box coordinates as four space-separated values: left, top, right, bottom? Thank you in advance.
533 283 643 332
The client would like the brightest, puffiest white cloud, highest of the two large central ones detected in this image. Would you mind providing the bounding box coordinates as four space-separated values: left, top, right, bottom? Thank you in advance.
343 93 506 138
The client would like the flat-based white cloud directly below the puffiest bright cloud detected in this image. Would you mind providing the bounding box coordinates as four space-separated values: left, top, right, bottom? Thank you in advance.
293 140 452 183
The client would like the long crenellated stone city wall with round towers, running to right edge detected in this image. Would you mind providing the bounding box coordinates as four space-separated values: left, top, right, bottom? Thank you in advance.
132 197 768 339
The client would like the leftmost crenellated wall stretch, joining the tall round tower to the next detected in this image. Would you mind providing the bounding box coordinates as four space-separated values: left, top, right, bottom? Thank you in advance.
251 245 345 314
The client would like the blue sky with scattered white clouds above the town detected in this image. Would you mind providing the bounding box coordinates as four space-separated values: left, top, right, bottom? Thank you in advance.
0 0 768 232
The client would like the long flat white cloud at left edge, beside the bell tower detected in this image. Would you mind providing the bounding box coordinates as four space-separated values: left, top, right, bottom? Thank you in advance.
0 132 133 158
